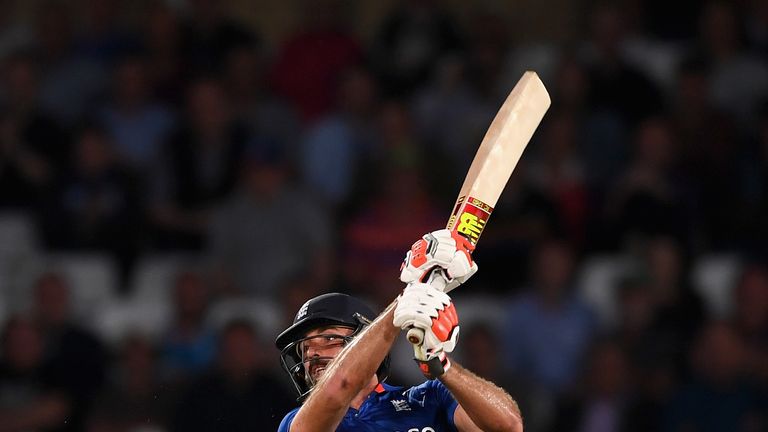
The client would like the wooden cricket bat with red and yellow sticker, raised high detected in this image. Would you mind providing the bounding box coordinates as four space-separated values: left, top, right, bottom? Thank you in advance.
408 71 550 353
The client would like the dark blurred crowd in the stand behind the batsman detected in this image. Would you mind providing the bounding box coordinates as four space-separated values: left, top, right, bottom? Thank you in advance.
0 0 768 432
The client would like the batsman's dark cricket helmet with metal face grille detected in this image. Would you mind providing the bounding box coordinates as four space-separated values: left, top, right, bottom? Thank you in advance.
275 293 389 400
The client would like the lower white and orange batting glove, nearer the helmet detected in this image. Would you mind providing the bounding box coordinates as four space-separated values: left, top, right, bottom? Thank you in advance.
393 282 459 379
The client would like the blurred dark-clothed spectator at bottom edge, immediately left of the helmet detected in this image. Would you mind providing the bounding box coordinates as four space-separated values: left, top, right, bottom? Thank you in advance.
171 321 294 432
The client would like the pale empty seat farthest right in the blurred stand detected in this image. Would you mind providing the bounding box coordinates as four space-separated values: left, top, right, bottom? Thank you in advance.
691 254 742 318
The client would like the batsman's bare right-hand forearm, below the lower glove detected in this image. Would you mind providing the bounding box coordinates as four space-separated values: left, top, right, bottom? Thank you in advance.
440 362 523 432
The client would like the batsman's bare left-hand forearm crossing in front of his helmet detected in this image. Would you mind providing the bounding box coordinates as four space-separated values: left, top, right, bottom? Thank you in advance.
291 303 400 431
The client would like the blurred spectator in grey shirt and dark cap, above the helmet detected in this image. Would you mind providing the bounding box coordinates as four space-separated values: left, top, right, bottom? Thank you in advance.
208 138 334 298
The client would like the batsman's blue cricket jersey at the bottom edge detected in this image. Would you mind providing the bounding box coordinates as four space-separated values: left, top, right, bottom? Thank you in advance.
278 380 458 432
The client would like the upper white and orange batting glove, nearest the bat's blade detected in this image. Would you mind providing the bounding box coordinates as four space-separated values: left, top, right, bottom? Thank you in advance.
400 229 477 292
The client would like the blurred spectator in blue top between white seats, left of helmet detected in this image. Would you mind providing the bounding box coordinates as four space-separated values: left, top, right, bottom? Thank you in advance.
160 271 216 381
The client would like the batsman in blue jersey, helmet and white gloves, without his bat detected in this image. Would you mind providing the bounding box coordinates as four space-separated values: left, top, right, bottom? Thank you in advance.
275 230 523 432
